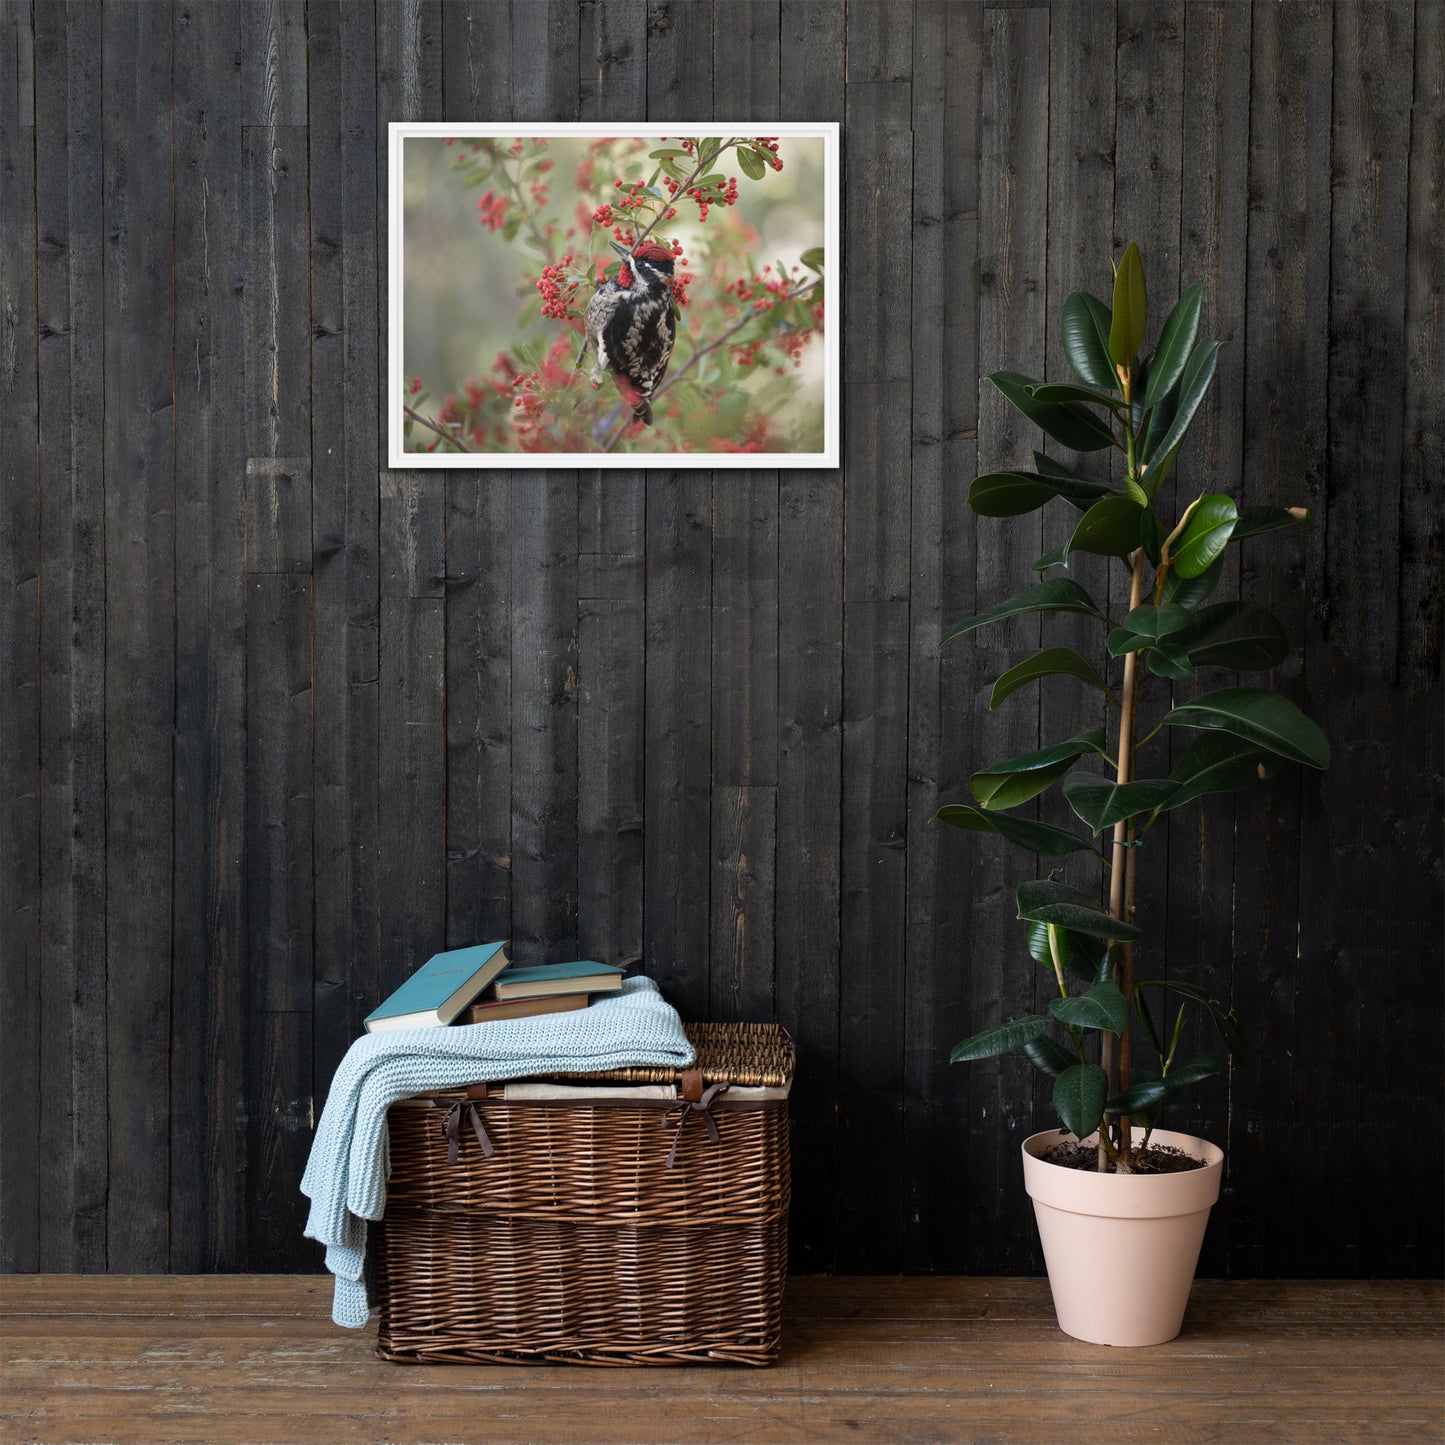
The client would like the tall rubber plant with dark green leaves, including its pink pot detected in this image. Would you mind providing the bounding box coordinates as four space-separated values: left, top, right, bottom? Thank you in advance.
938 246 1329 1345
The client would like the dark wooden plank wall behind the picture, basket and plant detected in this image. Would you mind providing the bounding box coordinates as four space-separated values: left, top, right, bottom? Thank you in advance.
0 0 1445 1274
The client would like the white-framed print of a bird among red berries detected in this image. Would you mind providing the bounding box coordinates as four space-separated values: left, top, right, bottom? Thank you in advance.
387 121 840 468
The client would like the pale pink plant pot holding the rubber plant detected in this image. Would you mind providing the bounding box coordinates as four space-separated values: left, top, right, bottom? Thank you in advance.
1023 1129 1224 1345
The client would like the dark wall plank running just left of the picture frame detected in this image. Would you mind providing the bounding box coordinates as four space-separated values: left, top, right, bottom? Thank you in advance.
306 0 384 1108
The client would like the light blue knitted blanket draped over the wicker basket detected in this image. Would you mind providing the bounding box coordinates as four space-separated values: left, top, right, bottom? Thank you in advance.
301 977 694 1329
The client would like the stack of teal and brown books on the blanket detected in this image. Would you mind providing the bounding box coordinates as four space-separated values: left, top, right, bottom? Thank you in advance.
366 942 623 1033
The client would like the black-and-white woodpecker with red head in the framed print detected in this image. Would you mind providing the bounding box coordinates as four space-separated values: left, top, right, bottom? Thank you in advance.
584 241 678 426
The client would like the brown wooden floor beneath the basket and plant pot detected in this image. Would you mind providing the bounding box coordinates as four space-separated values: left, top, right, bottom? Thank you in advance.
0 1274 1445 1445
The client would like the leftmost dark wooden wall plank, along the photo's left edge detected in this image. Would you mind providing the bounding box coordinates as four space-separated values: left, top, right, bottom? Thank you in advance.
0 0 39 1270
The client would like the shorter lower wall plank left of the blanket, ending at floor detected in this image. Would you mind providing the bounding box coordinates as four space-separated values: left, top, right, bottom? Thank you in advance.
246 572 315 1270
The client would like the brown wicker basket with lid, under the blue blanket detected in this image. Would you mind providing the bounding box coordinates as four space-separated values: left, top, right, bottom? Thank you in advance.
376 1025 793 1366
